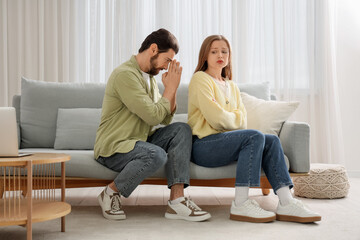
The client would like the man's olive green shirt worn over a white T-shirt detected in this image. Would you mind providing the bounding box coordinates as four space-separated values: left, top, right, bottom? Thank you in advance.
94 56 173 159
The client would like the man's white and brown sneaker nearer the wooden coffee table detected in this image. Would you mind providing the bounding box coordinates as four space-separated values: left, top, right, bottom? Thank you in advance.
98 188 126 220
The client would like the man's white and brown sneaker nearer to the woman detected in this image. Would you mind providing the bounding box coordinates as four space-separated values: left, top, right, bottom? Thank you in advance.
165 198 211 222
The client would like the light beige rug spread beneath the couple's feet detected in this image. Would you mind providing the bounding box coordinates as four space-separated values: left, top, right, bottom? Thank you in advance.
0 179 360 240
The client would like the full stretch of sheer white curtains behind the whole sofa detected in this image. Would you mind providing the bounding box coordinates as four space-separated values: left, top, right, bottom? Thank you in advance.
0 0 343 163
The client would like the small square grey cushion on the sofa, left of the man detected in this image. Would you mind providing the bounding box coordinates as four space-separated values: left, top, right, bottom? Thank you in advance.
54 108 101 149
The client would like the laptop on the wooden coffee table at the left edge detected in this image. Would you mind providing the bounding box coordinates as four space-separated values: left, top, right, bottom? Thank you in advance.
0 107 30 158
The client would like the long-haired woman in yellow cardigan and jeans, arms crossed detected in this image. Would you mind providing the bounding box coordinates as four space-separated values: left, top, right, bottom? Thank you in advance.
188 35 321 222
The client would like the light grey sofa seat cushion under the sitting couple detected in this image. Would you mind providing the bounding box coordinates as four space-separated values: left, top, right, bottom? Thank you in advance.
20 148 289 180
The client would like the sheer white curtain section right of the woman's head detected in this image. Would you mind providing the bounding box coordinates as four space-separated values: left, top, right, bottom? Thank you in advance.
232 0 344 163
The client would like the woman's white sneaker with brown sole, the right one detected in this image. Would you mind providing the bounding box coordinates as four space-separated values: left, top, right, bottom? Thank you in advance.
276 198 321 223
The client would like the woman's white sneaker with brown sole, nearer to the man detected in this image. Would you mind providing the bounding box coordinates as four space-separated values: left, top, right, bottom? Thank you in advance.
230 199 276 223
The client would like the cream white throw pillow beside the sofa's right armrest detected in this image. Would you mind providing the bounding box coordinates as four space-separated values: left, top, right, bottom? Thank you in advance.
241 92 300 135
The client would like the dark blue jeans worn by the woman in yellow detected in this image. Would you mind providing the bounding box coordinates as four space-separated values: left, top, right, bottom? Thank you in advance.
192 129 293 193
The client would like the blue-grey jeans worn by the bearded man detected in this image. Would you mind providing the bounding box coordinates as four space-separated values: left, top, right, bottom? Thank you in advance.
97 123 192 197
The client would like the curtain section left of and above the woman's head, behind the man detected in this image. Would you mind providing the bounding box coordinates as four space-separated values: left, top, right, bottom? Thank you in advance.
0 0 236 106
